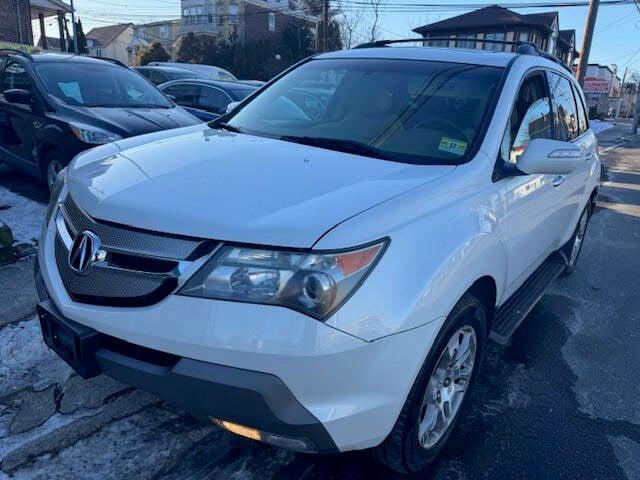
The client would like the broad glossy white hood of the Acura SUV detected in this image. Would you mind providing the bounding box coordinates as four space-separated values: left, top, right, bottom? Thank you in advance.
68 129 455 248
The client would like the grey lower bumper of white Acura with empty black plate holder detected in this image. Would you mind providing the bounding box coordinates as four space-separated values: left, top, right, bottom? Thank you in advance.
38 300 338 453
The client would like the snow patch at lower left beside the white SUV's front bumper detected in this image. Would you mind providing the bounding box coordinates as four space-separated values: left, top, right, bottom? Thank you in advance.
0 318 73 396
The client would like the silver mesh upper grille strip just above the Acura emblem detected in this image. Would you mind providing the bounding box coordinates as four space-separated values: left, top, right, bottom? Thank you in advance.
60 195 206 260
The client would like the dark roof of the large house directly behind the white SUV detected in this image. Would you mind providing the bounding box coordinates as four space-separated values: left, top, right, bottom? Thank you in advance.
413 5 558 34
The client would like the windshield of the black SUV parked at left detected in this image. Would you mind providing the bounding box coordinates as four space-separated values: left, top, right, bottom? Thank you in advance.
36 63 173 108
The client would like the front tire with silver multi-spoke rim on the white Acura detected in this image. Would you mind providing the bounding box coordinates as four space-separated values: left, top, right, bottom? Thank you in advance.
374 293 487 473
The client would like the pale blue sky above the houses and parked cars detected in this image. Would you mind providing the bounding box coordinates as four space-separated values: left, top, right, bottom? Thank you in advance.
34 0 640 76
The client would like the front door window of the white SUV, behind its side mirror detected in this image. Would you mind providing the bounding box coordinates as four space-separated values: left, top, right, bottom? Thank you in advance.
500 73 553 163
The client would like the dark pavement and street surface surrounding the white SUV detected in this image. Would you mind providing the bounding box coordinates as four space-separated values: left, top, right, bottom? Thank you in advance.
0 124 640 480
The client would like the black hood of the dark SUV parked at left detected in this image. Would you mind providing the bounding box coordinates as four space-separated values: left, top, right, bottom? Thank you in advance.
65 107 200 137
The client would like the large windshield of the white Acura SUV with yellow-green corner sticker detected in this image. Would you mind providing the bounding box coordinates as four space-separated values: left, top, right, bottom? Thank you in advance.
226 59 502 164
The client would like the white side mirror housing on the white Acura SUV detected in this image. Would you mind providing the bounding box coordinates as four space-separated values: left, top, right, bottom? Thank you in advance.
516 138 584 175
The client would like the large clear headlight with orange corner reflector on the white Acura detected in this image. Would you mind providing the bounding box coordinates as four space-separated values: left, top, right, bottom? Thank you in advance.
178 240 387 319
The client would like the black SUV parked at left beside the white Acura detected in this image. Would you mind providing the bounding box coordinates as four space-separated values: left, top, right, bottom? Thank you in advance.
0 50 200 186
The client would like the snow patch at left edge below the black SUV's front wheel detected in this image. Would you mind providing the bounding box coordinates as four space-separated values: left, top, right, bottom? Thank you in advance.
0 187 47 243
